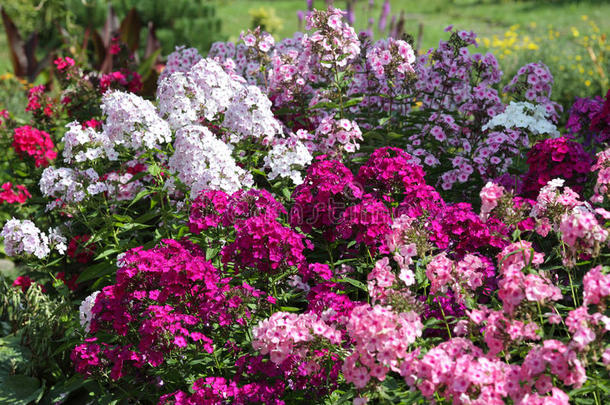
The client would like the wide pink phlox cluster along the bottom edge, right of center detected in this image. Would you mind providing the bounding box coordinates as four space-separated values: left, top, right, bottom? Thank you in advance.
401 338 586 405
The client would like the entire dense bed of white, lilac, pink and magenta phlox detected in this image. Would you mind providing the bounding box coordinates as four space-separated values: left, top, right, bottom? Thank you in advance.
0 8 610 405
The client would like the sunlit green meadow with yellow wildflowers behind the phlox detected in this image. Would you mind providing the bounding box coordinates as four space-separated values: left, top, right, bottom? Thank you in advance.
0 0 610 102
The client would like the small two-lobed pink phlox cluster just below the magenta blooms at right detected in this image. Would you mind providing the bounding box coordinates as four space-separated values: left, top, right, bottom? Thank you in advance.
426 252 486 303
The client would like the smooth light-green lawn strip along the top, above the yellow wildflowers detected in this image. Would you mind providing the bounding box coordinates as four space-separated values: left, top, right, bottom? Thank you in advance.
217 0 610 49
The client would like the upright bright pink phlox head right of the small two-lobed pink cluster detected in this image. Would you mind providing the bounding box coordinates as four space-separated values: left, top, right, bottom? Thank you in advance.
498 241 562 314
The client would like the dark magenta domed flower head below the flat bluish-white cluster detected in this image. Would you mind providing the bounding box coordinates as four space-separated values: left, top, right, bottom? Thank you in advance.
523 137 593 198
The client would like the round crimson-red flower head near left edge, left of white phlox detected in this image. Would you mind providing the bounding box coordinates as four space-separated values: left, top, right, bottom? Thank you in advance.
12 125 57 167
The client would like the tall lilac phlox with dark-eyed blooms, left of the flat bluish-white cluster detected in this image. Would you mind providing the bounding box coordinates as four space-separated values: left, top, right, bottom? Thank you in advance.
406 31 528 190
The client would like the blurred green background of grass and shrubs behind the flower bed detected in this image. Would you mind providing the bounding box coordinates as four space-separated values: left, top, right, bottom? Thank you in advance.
0 0 610 109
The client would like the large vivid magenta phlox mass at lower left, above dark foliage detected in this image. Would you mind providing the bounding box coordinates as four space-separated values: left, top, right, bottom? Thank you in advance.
71 240 270 380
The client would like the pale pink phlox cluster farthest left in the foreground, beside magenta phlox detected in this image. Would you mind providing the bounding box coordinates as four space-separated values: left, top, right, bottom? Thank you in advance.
252 312 341 366
